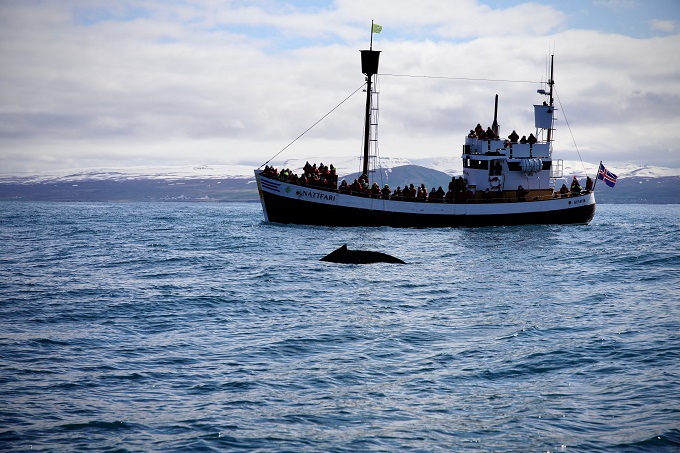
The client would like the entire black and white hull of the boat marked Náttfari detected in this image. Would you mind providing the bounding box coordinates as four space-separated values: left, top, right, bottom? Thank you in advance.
255 171 595 228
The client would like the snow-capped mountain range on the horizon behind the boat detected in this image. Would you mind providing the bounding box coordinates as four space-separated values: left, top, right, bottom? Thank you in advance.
0 157 680 203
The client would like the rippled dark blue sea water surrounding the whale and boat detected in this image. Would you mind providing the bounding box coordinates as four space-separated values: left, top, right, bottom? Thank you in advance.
0 202 680 452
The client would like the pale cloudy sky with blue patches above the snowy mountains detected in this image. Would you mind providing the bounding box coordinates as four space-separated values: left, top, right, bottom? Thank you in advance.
0 0 680 173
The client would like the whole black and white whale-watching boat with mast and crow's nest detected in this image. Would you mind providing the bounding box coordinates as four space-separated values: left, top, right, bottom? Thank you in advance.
255 35 595 228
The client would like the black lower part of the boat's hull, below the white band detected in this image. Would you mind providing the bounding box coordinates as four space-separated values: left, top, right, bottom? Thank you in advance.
260 192 595 228
